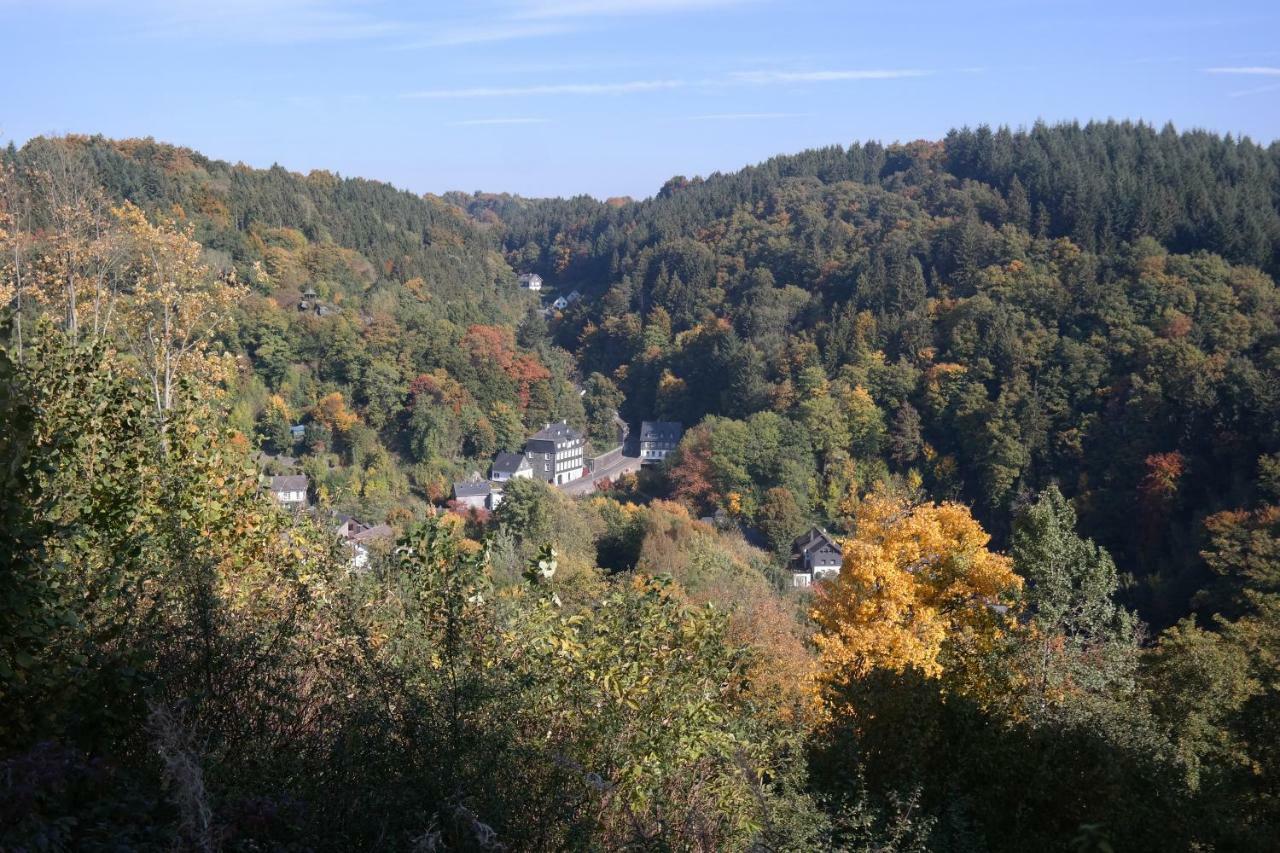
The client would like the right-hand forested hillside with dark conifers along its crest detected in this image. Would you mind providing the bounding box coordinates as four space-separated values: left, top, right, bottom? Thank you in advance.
452 123 1280 624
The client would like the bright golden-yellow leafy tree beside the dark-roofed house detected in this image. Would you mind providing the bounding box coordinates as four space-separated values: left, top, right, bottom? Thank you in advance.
813 494 1021 694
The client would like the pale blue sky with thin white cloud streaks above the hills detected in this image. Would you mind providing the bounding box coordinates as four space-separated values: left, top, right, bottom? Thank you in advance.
0 0 1280 197
